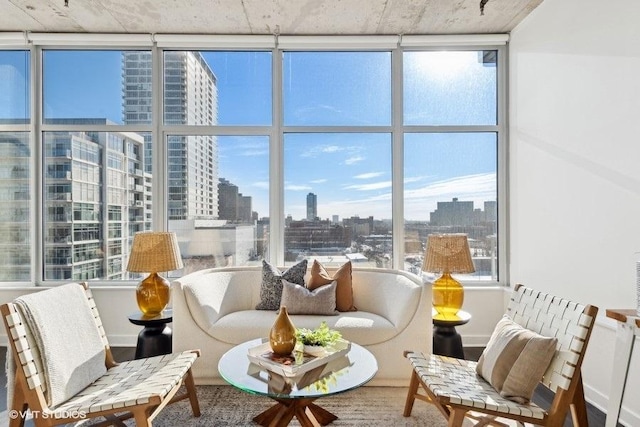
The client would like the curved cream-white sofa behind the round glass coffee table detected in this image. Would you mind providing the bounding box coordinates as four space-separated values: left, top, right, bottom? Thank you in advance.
172 266 432 386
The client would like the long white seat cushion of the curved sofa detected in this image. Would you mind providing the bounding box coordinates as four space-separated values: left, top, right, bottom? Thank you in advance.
210 310 398 345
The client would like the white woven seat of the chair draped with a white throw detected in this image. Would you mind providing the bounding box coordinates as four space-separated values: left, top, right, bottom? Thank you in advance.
49 351 198 416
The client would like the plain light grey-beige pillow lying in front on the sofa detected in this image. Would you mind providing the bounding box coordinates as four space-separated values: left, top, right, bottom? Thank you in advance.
280 279 338 316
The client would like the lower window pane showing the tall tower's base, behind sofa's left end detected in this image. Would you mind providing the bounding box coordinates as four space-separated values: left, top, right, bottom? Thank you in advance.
167 136 269 274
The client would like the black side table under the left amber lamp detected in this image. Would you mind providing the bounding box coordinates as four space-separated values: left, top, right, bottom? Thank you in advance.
129 309 173 359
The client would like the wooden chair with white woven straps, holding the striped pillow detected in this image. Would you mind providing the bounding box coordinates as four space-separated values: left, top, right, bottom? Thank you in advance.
403 284 598 427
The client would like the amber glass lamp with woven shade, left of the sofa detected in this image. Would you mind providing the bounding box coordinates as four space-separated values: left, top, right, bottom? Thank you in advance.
127 232 183 317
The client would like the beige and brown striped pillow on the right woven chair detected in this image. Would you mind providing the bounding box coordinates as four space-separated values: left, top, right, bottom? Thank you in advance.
476 316 558 403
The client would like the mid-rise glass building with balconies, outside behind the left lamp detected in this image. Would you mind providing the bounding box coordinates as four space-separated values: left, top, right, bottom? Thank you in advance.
43 119 151 280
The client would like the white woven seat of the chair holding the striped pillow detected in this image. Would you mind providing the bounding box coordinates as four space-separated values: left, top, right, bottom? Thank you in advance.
407 353 546 420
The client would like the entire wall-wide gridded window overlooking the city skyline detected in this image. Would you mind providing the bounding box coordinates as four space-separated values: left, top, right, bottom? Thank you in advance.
0 37 505 284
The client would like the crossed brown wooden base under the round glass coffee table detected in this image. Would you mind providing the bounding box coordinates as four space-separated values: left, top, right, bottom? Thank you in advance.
253 398 338 427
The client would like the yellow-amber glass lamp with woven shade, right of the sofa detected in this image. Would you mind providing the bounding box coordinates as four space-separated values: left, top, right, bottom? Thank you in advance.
422 234 475 315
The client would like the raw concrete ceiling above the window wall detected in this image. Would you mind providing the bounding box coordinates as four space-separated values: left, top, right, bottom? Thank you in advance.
0 0 542 35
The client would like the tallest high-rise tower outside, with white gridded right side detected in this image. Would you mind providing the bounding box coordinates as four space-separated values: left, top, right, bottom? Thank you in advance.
122 51 218 220
